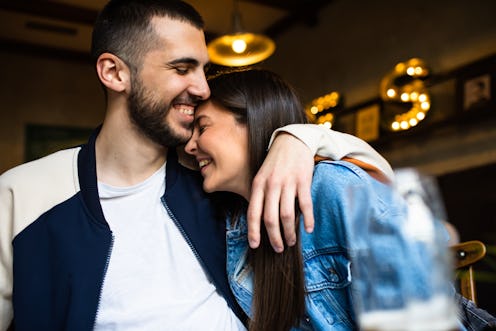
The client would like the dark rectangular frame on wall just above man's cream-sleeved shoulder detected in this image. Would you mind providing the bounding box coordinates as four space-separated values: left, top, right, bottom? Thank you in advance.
24 124 93 162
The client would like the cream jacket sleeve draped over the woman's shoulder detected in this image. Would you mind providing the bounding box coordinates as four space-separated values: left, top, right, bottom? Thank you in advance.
269 124 394 182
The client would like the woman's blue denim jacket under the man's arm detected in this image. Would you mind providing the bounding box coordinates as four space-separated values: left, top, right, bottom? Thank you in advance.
226 161 432 330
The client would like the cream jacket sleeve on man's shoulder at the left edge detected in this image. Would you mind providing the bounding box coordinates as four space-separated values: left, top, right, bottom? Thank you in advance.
0 147 80 331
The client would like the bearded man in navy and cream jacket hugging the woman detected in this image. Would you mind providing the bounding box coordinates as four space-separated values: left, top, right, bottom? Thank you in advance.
0 0 396 330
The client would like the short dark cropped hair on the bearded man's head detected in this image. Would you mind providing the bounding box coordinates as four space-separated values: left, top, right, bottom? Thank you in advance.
91 0 204 70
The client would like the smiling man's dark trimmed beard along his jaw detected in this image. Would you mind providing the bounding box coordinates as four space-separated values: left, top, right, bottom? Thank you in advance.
128 80 192 147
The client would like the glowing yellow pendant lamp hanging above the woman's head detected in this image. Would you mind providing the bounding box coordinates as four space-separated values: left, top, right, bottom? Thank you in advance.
208 0 276 67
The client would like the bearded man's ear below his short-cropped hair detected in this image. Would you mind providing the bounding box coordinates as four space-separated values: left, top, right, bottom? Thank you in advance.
96 53 131 92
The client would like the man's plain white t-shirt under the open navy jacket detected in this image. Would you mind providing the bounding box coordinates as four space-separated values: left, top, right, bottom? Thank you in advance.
95 165 245 331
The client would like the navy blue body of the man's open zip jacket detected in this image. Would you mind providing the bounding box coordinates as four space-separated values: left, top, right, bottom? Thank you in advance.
0 130 245 331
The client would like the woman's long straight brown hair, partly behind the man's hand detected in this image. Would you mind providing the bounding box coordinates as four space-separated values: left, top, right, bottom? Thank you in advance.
209 69 307 331
